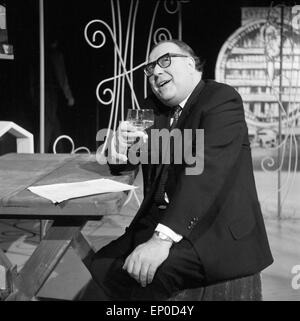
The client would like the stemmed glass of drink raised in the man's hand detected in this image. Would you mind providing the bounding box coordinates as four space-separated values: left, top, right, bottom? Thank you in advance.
126 109 154 131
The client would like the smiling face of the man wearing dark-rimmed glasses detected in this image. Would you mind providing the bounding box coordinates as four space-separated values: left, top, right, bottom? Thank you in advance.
149 42 195 107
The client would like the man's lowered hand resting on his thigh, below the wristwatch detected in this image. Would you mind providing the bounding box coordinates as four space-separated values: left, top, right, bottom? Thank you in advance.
123 235 172 287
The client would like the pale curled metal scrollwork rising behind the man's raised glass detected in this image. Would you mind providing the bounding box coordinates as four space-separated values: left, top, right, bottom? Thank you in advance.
84 0 188 159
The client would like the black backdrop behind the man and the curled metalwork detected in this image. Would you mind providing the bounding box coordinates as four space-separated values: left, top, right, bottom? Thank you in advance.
0 0 299 150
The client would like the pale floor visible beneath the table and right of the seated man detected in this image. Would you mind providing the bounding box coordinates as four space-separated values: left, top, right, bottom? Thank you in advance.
0 168 300 301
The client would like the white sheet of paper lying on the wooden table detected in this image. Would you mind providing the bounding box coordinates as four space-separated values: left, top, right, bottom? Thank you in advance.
28 178 137 203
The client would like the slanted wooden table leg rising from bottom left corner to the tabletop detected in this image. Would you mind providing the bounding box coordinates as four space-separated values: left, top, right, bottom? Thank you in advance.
7 218 86 301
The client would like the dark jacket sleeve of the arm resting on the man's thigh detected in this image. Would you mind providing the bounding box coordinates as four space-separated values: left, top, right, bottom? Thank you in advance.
159 86 247 238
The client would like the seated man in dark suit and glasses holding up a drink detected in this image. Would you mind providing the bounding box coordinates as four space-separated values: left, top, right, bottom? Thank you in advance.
87 40 273 300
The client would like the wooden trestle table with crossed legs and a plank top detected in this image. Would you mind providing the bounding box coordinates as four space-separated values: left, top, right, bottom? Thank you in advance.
0 154 135 300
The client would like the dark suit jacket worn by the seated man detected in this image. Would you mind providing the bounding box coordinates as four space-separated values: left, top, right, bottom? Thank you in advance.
114 80 273 284
